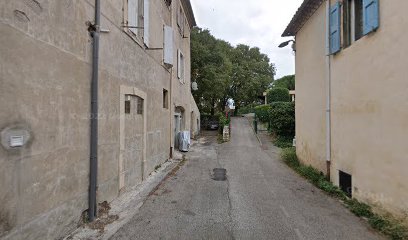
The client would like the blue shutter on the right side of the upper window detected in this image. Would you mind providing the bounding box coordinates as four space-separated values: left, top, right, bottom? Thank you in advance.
363 0 380 35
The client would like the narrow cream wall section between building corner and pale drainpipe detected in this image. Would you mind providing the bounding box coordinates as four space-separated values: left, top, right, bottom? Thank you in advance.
296 2 326 172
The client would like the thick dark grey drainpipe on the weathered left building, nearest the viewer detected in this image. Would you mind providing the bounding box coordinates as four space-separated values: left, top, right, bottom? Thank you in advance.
88 0 101 222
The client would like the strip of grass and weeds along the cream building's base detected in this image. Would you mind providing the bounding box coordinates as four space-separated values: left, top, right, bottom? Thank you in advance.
281 147 408 240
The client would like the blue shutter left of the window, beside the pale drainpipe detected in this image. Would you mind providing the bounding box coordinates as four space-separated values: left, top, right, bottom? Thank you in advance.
329 2 341 54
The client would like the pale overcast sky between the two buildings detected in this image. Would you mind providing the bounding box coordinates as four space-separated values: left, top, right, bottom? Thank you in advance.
191 0 303 78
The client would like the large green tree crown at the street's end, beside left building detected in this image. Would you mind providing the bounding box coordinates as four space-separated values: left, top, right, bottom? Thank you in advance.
191 28 275 115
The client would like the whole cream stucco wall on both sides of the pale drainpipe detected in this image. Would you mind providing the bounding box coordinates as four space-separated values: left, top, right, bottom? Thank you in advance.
296 1 408 221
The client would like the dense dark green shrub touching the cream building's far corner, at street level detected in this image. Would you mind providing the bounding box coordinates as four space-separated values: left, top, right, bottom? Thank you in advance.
269 102 295 137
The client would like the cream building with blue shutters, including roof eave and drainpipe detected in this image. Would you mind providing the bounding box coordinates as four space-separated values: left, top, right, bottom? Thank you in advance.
283 0 408 222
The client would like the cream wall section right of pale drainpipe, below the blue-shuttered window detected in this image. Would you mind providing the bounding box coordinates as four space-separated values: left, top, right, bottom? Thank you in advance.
331 0 408 218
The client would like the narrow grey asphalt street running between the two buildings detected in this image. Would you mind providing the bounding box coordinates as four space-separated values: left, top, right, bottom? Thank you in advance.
111 118 382 239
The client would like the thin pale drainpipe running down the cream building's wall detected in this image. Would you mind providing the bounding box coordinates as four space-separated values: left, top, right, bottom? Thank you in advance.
326 0 331 180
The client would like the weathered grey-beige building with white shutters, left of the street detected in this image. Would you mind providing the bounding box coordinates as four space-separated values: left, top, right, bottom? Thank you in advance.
0 0 200 239
